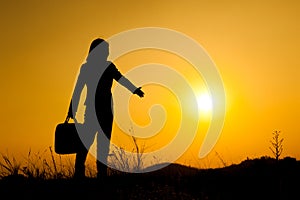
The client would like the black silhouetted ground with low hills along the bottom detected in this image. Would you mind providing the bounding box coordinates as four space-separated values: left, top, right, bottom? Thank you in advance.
0 158 300 200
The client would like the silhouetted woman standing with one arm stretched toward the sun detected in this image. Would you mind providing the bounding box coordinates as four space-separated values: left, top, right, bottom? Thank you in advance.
68 38 144 177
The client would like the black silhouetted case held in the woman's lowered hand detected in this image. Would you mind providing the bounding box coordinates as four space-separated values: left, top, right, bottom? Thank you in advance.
54 117 83 154
